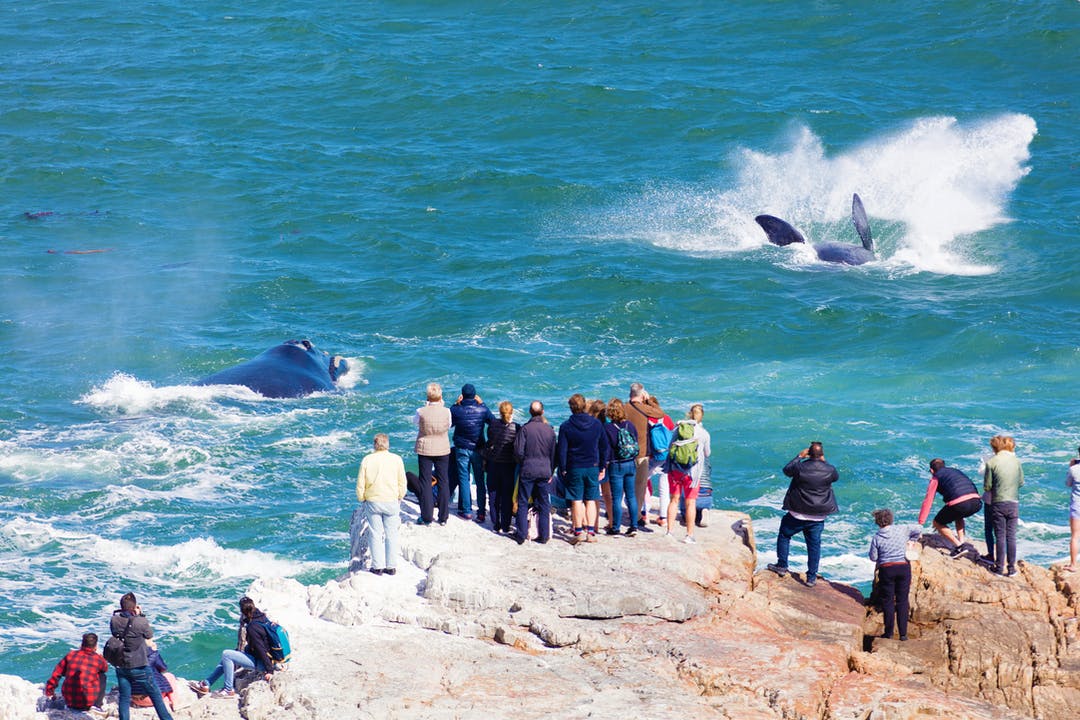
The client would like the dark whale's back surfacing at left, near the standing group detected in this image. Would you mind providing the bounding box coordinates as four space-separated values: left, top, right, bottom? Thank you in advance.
195 340 349 398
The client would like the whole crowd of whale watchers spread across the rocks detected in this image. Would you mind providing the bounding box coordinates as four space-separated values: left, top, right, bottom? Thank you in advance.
43 383 1080 720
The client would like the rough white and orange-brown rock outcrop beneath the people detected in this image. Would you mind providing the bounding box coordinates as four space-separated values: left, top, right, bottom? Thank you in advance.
8 500 1080 720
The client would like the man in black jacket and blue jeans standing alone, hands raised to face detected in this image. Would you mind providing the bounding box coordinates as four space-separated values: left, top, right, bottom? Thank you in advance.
768 440 840 587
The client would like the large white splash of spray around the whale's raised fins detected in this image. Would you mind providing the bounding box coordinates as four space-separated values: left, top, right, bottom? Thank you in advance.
605 114 1036 274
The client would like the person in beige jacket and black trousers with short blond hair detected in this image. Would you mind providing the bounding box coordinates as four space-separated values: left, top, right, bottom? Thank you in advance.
413 382 451 525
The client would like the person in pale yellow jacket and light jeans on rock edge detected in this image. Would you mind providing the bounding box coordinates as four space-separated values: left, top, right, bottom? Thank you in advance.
356 433 405 575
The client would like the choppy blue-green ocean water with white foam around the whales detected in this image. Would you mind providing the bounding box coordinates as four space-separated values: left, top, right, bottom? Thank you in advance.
0 0 1080 681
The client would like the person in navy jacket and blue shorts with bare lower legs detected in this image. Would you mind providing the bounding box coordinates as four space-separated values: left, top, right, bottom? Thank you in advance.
558 393 608 545
